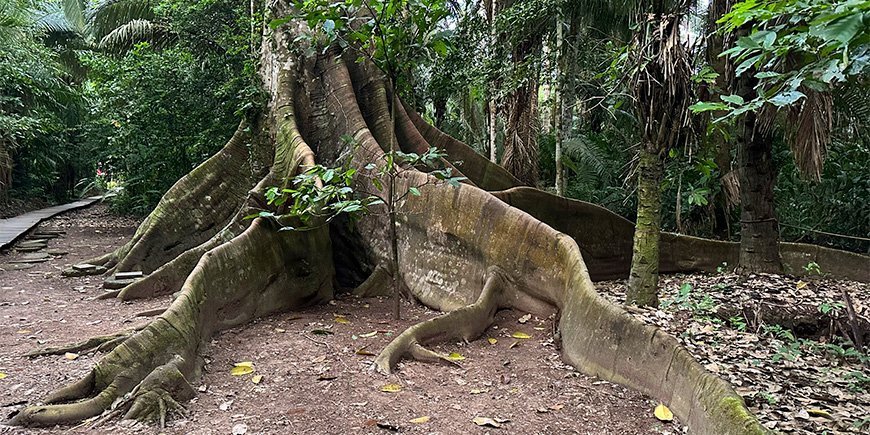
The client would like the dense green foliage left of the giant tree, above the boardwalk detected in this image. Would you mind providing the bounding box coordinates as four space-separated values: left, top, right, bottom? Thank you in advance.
0 0 260 214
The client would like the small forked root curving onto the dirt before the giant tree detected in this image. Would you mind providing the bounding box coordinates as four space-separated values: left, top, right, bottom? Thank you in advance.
374 267 508 374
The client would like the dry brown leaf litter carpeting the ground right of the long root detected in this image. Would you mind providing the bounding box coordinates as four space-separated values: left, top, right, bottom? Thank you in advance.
596 273 870 435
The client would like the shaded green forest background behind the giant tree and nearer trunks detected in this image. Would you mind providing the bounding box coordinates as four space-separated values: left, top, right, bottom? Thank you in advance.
0 0 870 253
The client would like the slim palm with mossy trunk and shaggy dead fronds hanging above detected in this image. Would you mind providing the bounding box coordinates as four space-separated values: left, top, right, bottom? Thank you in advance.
626 0 692 306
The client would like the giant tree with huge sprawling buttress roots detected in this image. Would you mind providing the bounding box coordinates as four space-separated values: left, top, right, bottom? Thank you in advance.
10 1 765 434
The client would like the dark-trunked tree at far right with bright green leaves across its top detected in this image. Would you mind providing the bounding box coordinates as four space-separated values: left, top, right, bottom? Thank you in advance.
693 0 870 272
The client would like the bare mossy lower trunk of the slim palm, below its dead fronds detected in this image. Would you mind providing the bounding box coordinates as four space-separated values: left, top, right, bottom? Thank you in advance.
625 147 663 306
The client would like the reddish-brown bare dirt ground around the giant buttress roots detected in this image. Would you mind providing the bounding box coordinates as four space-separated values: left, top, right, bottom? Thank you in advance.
0 206 684 434
